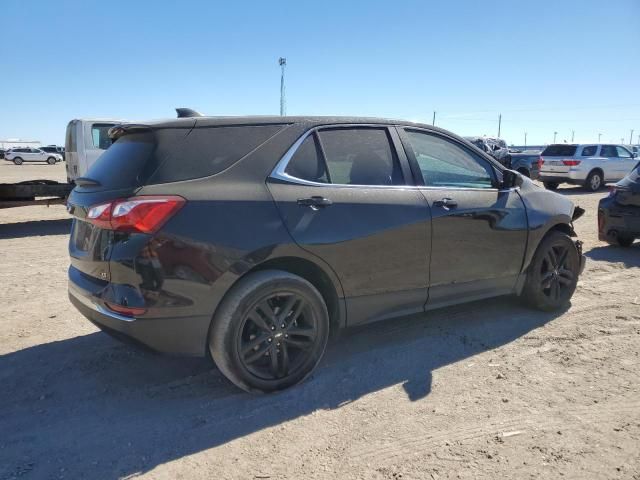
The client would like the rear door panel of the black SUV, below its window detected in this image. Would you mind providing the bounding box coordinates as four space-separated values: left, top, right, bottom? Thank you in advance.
268 180 431 325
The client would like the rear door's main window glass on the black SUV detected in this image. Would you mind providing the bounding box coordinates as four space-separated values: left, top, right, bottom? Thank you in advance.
319 127 404 185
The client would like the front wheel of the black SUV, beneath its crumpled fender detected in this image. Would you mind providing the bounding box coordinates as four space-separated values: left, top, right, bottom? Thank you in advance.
522 231 580 312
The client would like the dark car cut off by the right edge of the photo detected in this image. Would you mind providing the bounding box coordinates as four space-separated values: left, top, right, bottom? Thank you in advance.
598 163 640 247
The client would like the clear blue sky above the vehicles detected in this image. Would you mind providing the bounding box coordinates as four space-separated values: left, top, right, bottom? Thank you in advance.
0 0 640 144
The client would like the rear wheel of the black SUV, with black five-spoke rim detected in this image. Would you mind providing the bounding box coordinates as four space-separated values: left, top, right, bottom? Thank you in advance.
209 270 329 393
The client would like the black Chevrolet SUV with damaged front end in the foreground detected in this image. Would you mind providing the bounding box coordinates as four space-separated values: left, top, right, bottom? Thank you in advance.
68 117 584 392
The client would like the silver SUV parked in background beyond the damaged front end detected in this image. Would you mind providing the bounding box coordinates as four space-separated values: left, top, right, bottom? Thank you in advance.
540 143 637 192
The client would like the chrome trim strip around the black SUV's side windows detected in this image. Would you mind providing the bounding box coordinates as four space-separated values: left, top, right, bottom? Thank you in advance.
269 123 519 193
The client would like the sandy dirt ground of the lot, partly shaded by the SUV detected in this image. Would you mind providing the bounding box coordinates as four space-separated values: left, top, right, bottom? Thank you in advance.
0 163 640 480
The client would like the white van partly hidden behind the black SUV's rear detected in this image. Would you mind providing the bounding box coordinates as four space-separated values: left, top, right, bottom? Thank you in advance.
65 119 125 183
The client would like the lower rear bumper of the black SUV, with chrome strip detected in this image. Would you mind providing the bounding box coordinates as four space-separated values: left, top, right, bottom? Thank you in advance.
69 280 211 356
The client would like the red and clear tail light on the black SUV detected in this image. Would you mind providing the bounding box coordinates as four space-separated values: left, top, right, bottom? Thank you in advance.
87 195 185 233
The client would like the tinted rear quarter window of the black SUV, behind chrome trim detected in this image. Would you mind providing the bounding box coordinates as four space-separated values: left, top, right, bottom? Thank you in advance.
148 125 285 183
